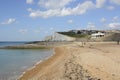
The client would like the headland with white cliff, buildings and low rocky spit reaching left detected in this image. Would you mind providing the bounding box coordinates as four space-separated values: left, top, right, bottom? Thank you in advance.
1 30 120 49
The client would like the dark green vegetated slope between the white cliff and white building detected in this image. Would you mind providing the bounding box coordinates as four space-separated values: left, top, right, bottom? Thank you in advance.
58 32 89 38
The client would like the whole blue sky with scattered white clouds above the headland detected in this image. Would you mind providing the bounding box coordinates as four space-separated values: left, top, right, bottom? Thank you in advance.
0 0 120 41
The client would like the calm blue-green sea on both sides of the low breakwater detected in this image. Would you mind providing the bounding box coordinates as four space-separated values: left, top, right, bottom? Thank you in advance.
0 42 53 80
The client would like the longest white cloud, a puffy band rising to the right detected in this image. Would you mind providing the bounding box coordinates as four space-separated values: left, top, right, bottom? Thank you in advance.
29 1 94 18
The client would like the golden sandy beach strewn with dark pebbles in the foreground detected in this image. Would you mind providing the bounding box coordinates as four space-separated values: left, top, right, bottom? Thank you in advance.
19 42 120 80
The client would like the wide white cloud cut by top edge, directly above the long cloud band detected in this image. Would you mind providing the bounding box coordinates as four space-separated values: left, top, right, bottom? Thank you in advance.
38 0 74 9
